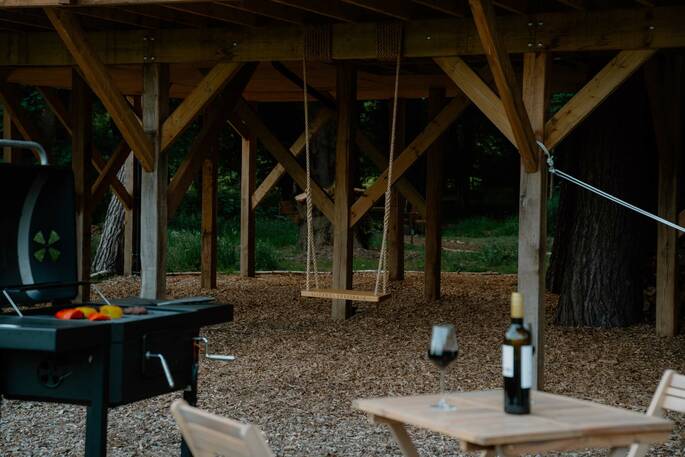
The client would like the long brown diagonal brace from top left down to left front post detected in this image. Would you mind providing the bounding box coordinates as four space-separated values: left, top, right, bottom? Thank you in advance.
45 8 154 171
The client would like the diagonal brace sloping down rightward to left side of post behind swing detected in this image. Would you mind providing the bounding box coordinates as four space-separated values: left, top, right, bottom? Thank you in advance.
230 99 334 221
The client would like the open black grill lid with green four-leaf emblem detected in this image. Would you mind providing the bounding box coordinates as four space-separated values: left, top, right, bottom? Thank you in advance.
0 164 78 305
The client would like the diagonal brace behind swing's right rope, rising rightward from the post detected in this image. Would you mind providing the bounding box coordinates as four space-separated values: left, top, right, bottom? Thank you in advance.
350 96 469 226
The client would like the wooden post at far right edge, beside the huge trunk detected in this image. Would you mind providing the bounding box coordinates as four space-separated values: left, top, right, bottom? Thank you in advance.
645 55 683 336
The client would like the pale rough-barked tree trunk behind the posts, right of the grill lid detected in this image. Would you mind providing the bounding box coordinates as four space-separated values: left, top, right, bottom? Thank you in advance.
91 167 126 274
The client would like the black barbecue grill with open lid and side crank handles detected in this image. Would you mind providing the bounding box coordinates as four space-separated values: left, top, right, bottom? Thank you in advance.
0 144 233 456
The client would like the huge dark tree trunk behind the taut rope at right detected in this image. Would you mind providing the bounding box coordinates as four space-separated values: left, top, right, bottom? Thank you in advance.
548 76 656 327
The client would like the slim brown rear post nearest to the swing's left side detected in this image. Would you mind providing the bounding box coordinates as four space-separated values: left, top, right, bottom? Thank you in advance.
240 132 257 278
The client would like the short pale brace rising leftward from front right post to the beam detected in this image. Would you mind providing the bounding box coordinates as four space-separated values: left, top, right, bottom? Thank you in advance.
434 57 516 146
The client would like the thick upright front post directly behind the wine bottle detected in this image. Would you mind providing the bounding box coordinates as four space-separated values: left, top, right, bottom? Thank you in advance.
518 52 549 389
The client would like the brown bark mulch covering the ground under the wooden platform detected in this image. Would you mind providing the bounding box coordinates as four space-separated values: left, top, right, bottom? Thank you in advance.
0 273 685 456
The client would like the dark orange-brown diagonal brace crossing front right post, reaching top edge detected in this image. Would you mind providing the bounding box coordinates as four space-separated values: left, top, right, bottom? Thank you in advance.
469 0 538 173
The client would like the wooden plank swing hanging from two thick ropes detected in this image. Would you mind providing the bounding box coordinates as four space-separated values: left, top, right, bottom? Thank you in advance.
300 26 402 303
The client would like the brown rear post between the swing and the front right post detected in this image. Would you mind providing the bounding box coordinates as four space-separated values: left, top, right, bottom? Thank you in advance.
424 87 445 302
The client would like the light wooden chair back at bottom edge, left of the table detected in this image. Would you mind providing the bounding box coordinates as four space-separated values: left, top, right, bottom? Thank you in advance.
171 400 274 457
